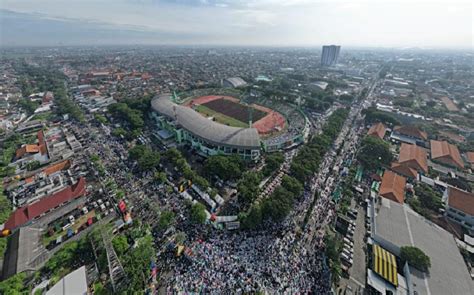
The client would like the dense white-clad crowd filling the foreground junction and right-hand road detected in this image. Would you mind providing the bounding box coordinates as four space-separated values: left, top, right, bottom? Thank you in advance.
165 100 362 294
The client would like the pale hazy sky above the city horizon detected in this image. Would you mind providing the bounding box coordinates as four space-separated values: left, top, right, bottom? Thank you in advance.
0 0 474 48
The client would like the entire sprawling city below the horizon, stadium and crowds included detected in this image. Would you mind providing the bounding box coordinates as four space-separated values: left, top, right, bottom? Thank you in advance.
0 44 474 294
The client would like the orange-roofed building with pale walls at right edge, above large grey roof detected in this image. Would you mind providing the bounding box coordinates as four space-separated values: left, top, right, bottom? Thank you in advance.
445 186 474 233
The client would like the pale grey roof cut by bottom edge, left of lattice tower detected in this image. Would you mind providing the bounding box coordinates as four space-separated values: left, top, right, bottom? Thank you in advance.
46 265 91 295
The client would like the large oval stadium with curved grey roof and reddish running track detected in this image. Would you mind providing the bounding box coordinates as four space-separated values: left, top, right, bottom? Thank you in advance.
151 91 309 161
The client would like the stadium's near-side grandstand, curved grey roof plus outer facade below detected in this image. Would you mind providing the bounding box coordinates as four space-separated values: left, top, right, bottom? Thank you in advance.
151 94 261 161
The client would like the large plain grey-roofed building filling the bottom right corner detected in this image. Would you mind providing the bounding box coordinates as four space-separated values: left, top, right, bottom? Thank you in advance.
367 198 474 295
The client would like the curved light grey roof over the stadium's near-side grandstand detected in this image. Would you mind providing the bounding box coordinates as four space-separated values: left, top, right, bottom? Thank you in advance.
151 93 260 149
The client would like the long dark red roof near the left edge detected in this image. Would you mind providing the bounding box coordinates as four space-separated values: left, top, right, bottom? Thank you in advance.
5 177 86 230
